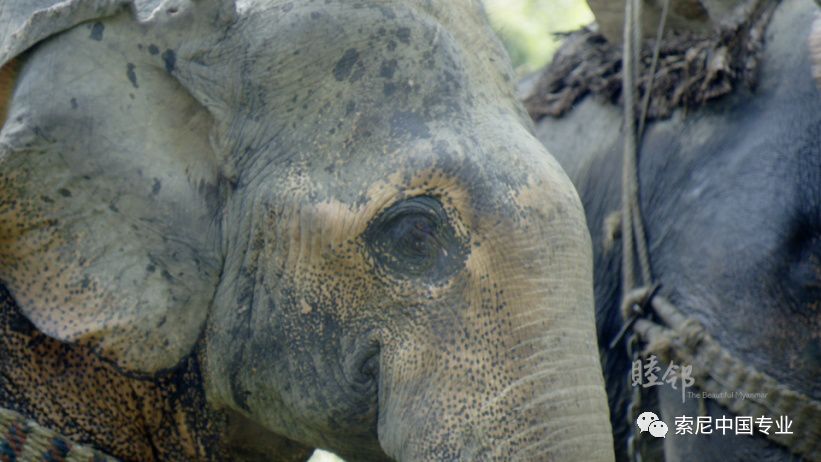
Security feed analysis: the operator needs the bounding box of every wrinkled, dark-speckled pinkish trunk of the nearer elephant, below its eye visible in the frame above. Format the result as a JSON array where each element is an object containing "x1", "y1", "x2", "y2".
[{"x1": 378, "y1": 204, "x2": 613, "y2": 461}]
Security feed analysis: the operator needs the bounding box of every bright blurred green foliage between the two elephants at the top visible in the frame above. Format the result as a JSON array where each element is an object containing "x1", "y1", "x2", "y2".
[{"x1": 484, "y1": 0, "x2": 593, "y2": 75}]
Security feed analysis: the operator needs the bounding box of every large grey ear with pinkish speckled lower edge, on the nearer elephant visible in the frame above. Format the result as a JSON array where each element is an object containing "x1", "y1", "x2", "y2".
[{"x1": 0, "y1": 0, "x2": 233, "y2": 373}]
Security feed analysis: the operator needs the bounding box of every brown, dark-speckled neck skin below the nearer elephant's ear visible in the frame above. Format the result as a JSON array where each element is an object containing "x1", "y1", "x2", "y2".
[{"x1": 0, "y1": 284, "x2": 225, "y2": 461}]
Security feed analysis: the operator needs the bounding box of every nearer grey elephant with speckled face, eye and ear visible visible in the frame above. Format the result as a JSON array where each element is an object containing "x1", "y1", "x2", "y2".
[{"x1": 0, "y1": 0, "x2": 613, "y2": 461}]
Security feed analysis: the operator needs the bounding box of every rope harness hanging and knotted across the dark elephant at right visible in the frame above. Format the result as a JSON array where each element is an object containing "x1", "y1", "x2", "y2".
[{"x1": 610, "y1": 0, "x2": 821, "y2": 462}]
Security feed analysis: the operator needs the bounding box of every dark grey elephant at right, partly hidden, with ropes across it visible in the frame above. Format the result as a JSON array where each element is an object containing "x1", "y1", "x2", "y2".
[{"x1": 522, "y1": 0, "x2": 821, "y2": 461}]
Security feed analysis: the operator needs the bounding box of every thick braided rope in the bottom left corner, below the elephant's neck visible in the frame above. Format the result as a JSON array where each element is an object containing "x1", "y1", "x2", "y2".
[{"x1": 0, "y1": 408, "x2": 117, "y2": 462}]
